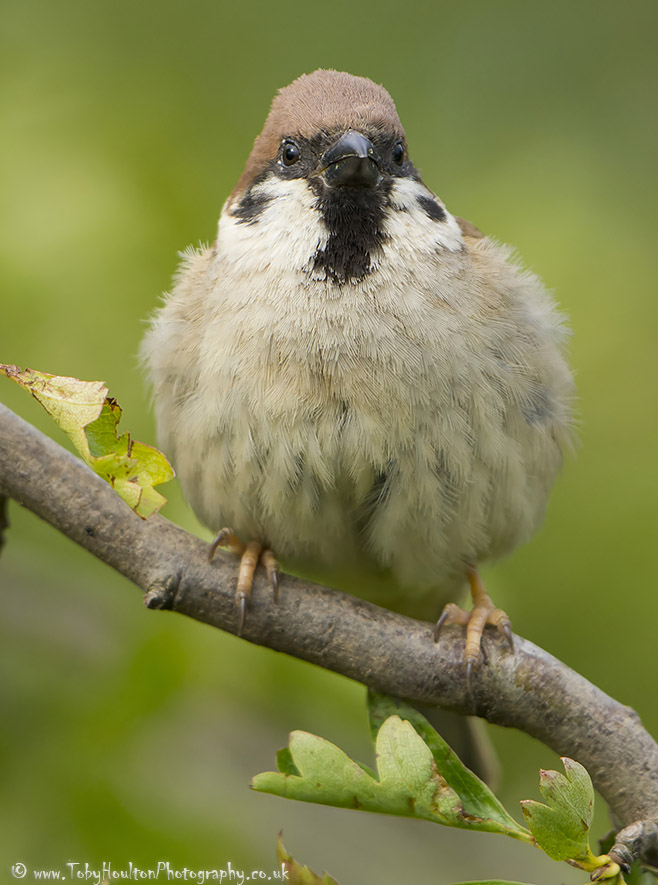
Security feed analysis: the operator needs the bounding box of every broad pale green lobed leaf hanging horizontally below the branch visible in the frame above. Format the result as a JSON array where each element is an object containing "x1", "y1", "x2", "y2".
[{"x1": 251, "y1": 698, "x2": 531, "y2": 841}]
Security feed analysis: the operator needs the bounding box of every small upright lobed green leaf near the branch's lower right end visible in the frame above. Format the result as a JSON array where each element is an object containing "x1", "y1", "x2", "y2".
[{"x1": 521, "y1": 757, "x2": 596, "y2": 866}]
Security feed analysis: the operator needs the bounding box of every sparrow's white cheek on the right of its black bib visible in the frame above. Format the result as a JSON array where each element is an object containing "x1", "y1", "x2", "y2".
[{"x1": 386, "y1": 178, "x2": 464, "y2": 253}]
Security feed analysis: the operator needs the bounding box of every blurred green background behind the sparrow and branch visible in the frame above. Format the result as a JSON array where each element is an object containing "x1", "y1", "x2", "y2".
[{"x1": 0, "y1": 0, "x2": 658, "y2": 885}]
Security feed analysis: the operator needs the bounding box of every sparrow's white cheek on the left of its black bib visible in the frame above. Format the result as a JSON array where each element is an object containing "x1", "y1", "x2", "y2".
[{"x1": 217, "y1": 178, "x2": 328, "y2": 272}]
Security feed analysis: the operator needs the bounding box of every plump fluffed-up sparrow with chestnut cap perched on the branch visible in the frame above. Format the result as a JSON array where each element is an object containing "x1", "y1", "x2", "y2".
[{"x1": 142, "y1": 69, "x2": 573, "y2": 696}]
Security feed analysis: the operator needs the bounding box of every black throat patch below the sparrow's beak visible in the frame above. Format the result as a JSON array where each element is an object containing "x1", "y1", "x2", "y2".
[{"x1": 313, "y1": 180, "x2": 392, "y2": 284}]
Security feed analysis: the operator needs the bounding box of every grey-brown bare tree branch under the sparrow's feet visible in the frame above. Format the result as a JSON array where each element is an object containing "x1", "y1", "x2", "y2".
[{"x1": 0, "y1": 405, "x2": 658, "y2": 865}]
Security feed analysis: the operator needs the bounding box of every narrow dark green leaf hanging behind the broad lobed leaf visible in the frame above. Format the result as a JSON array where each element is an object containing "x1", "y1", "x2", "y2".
[{"x1": 368, "y1": 691, "x2": 531, "y2": 842}]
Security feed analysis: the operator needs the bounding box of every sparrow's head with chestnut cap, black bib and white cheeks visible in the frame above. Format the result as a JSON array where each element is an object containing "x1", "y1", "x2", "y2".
[{"x1": 220, "y1": 70, "x2": 460, "y2": 284}]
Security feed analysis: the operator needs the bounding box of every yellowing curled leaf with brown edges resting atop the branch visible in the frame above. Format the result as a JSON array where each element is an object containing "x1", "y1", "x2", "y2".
[{"x1": 0, "y1": 364, "x2": 174, "y2": 519}]
